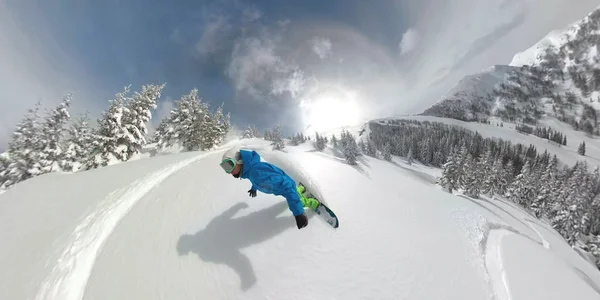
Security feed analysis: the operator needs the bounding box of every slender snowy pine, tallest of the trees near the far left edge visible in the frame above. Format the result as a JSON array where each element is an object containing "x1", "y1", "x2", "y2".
[{"x1": 39, "y1": 95, "x2": 72, "y2": 174}]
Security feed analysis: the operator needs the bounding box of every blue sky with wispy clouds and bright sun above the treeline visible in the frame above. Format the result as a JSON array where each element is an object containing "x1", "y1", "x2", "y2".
[{"x1": 0, "y1": 0, "x2": 597, "y2": 144}]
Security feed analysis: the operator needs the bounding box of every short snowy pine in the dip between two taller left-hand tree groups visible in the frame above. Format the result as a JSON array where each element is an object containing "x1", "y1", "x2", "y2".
[{"x1": 64, "y1": 113, "x2": 94, "y2": 172}]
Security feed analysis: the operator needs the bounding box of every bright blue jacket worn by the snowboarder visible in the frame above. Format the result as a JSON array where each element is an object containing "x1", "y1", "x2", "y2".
[{"x1": 240, "y1": 150, "x2": 304, "y2": 216}]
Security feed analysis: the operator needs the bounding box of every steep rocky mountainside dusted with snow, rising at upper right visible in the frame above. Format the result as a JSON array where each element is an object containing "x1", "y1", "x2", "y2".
[{"x1": 422, "y1": 8, "x2": 600, "y2": 135}]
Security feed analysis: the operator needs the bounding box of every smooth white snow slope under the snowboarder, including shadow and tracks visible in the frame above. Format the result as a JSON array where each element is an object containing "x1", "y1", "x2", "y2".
[{"x1": 0, "y1": 140, "x2": 600, "y2": 300}]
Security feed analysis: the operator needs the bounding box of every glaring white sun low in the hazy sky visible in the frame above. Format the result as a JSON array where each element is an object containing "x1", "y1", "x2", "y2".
[{"x1": 301, "y1": 88, "x2": 361, "y2": 132}]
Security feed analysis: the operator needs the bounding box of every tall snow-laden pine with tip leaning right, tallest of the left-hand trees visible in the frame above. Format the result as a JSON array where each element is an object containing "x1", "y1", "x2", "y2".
[{"x1": 122, "y1": 84, "x2": 165, "y2": 160}]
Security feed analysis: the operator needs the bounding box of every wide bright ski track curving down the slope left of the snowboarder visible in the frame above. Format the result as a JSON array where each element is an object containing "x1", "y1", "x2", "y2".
[{"x1": 35, "y1": 152, "x2": 215, "y2": 300}]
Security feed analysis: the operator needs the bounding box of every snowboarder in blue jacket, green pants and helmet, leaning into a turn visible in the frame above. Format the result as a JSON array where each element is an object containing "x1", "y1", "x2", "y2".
[{"x1": 221, "y1": 147, "x2": 319, "y2": 229}]
